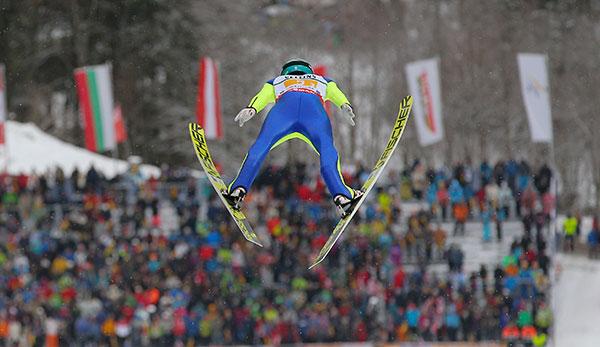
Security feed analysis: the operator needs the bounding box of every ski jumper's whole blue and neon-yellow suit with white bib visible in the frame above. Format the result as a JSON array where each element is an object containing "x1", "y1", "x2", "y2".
[{"x1": 229, "y1": 74, "x2": 354, "y2": 198}]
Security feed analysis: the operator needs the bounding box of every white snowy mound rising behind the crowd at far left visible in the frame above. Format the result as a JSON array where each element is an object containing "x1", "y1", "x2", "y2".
[{"x1": 0, "y1": 121, "x2": 160, "y2": 178}]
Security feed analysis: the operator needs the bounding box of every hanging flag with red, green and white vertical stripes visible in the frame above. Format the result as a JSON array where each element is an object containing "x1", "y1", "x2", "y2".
[{"x1": 75, "y1": 64, "x2": 116, "y2": 152}]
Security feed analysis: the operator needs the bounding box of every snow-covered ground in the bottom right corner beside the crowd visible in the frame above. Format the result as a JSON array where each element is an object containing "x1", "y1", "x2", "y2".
[{"x1": 552, "y1": 254, "x2": 600, "y2": 347}]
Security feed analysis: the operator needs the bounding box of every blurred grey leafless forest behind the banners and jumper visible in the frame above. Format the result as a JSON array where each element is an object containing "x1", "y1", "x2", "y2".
[{"x1": 0, "y1": 0, "x2": 600, "y2": 207}]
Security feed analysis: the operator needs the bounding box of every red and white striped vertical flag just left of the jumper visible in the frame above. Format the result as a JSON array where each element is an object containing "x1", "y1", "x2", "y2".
[{"x1": 196, "y1": 57, "x2": 223, "y2": 139}]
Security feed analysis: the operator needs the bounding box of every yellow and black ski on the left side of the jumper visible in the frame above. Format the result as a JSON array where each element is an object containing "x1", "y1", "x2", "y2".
[{"x1": 189, "y1": 123, "x2": 263, "y2": 247}]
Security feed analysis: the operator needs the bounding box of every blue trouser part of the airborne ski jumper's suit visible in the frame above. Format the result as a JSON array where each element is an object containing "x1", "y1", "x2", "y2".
[{"x1": 229, "y1": 91, "x2": 353, "y2": 198}]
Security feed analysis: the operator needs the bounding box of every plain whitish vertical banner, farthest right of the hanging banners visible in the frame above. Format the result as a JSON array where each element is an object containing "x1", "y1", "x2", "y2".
[{"x1": 517, "y1": 53, "x2": 552, "y2": 143}]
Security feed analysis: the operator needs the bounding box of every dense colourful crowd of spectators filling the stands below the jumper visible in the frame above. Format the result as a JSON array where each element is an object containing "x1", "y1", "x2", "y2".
[{"x1": 0, "y1": 159, "x2": 551, "y2": 346}]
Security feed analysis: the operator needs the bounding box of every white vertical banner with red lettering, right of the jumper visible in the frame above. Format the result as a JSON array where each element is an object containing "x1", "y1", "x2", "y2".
[{"x1": 406, "y1": 58, "x2": 444, "y2": 146}]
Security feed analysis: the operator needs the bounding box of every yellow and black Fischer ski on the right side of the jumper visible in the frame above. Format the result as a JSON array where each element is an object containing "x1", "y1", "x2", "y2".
[{"x1": 309, "y1": 95, "x2": 413, "y2": 269}]
